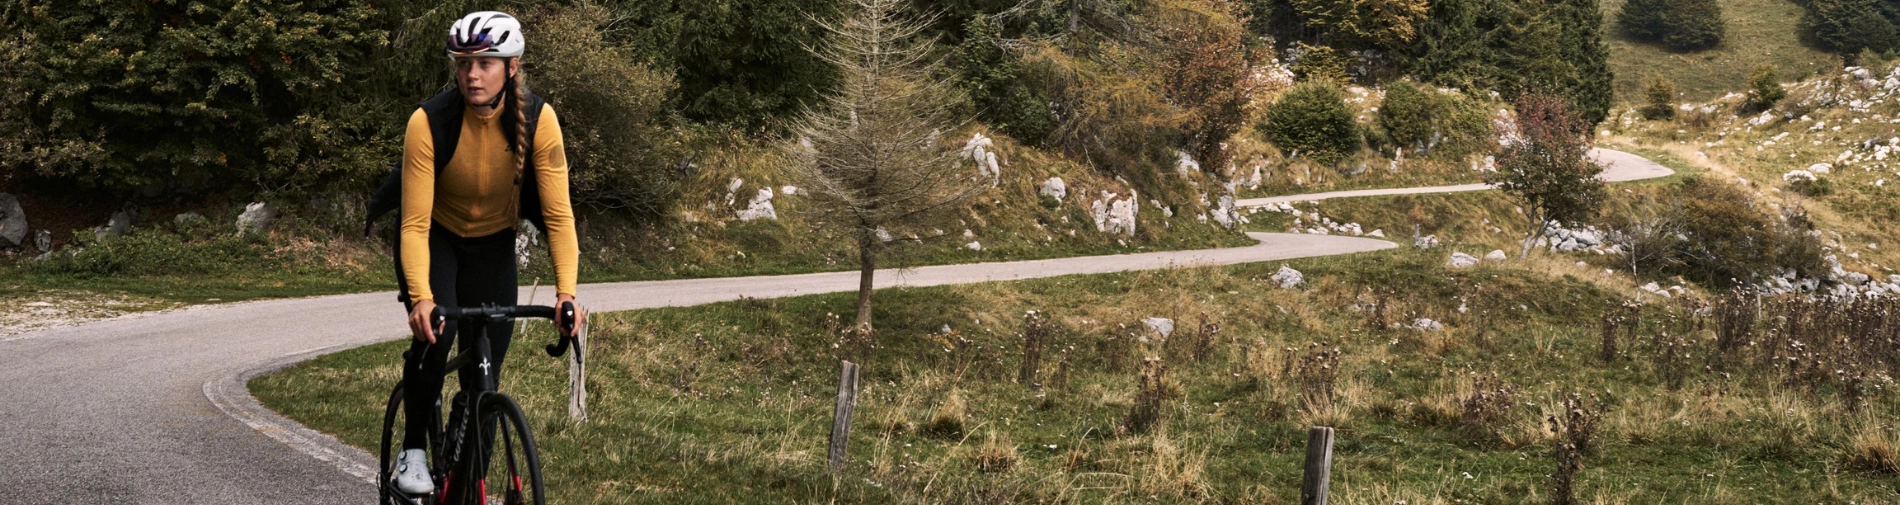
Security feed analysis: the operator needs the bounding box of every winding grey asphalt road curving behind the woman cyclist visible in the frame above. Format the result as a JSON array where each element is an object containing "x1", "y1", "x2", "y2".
[{"x1": 0, "y1": 146, "x2": 1668, "y2": 505}]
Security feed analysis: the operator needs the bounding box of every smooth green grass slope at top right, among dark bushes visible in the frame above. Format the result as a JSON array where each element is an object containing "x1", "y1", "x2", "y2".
[{"x1": 1602, "y1": 0, "x2": 1841, "y2": 104}]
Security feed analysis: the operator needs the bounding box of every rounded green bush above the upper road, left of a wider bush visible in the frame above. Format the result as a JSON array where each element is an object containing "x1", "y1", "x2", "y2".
[{"x1": 1260, "y1": 80, "x2": 1359, "y2": 163}]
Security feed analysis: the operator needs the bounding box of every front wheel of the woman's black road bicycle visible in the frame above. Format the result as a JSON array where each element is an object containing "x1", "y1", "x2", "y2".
[{"x1": 464, "y1": 393, "x2": 547, "y2": 505}]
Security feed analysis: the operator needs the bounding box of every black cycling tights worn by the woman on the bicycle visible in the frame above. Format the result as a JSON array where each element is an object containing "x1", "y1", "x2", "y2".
[{"x1": 403, "y1": 226, "x2": 517, "y2": 450}]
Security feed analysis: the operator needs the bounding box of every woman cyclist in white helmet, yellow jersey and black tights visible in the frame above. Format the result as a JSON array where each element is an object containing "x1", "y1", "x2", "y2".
[{"x1": 395, "y1": 11, "x2": 585, "y2": 494}]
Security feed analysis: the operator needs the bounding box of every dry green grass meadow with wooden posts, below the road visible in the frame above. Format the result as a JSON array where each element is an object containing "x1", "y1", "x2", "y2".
[{"x1": 251, "y1": 251, "x2": 1900, "y2": 503}]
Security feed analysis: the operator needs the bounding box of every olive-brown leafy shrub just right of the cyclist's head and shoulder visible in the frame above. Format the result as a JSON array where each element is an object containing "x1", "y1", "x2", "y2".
[{"x1": 523, "y1": 4, "x2": 684, "y2": 218}]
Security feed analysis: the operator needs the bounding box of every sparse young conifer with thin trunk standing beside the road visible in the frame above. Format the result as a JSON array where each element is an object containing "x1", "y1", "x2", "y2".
[{"x1": 785, "y1": 0, "x2": 990, "y2": 334}]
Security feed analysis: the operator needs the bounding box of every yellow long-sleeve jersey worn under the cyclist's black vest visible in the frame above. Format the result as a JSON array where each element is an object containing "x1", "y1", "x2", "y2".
[{"x1": 401, "y1": 106, "x2": 580, "y2": 302}]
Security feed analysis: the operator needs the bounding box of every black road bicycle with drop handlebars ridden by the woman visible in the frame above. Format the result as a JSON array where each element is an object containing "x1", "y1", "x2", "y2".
[{"x1": 376, "y1": 302, "x2": 581, "y2": 505}]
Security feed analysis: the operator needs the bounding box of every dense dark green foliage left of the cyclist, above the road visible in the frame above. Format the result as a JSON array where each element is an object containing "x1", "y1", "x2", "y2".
[{"x1": 0, "y1": 0, "x2": 410, "y2": 190}]
